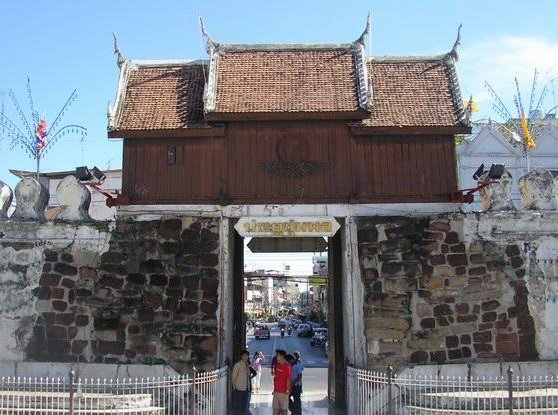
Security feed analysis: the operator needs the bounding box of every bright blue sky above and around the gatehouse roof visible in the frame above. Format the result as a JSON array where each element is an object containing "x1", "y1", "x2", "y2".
[{"x1": 0, "y1": 0, "x2": 558, "y2": 190}]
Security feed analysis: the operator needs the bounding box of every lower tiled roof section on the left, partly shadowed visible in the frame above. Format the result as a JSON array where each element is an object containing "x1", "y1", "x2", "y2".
[{"x1": 115, "y1": 63, "x2": 207, "y2": 131}]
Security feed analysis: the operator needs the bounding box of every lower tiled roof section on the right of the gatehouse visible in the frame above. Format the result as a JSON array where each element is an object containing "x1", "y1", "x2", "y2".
[{"x1": 362, "y1": 56, "x2": 468, "y2": 127}]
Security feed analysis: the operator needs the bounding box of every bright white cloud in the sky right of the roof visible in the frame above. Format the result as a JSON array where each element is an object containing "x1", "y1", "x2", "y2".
[{"x1": 459, "y1": 36, "x2": 558, "y2": 118}]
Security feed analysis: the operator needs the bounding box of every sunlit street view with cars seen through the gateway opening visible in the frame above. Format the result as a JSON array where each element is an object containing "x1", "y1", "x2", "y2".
[{"x1": 244, "y1": 238, "x2": 329, "y2": 414}]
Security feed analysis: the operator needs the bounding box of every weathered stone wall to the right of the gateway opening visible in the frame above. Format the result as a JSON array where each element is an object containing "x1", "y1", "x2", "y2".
[{"x1": 358, "y1": 213, "x2": 558, "y2": 366}]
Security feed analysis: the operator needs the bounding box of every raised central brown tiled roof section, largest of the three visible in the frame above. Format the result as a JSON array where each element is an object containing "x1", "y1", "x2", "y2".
[{"x1": 213, "y1": 48, "x2": 360, "y2": 114}]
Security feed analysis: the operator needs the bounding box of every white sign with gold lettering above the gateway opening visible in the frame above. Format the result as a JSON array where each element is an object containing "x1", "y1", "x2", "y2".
[{"x1": 235, "y1": 217, "x2": 339, "y2": 238}]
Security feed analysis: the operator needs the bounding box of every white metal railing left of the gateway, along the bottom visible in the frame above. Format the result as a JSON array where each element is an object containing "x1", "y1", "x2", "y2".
[{"x1": 0, "y1": 367, "x2": 228, "y2": 415}]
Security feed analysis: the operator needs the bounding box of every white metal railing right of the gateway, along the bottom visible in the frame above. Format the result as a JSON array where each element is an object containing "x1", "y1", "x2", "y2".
[{"x1": 347, "y1": 367, "x2": 558, "y2": 415}]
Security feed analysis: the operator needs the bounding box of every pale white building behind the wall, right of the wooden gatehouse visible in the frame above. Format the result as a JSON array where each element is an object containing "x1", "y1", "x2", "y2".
[{"x1": 457, "y1": 118, "x2": 558, "y2": 211}]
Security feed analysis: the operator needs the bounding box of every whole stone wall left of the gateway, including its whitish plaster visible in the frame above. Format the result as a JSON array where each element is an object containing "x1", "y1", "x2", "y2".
[{"x1": 0, "y1": 217, "x2": 219, "y2": 370}]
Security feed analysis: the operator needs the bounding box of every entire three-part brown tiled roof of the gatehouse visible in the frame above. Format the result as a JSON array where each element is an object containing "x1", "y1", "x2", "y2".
[{"x1": 109, "y1": 44, "x2": 465, "y2": 137}]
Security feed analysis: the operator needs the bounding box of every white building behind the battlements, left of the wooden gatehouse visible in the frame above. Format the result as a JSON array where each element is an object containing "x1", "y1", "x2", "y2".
[{"x1": 10, "y1": 169, "x2": 122, "y2": 220}]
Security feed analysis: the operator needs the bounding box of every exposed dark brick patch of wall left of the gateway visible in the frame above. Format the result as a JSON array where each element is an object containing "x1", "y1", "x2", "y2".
[{"x1": 27, "y1": 218, "x2": 219, "y2": 370}]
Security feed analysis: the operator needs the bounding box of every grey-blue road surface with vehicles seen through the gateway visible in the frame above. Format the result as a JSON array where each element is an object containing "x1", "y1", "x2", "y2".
[{"x1": 246, "y1": 325, "x2": 327, "y2": 368}]
